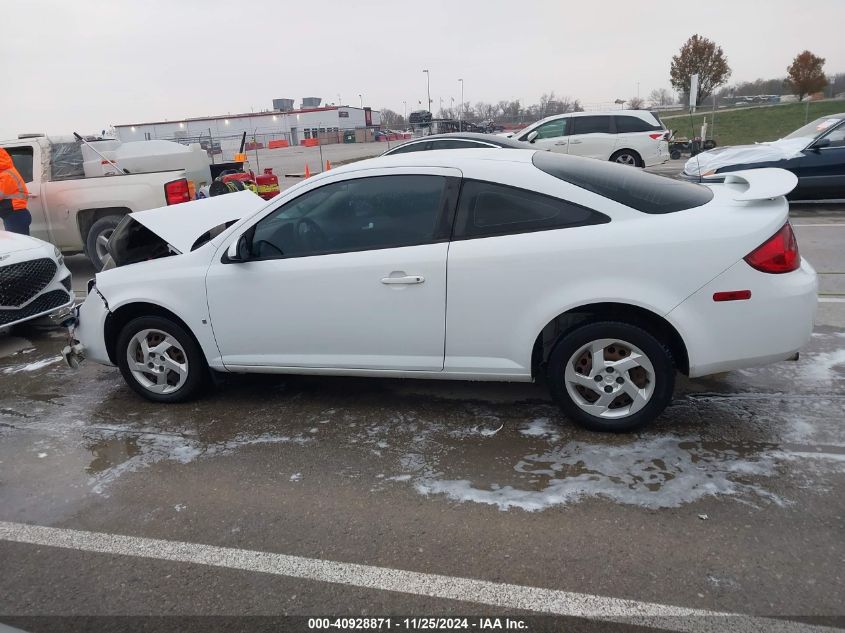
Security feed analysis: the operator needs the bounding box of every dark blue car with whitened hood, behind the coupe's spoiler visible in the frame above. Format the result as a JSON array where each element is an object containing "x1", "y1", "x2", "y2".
[{"x1": 683, "y1": 113, "x2": 845, "y2": 200}]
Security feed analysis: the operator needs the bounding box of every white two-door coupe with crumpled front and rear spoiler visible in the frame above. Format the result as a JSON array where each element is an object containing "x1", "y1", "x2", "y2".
[{"x1": 75, "y1": 149, "x2": 817, "y2": 431}]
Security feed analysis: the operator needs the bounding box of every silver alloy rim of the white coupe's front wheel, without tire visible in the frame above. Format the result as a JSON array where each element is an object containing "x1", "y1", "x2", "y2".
[{"x1": 126, "y1": 329, "x2": 188, "y2": 394}]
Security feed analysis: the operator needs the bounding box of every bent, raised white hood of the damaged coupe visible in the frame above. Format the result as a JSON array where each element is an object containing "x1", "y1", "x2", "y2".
[{"x1": 130, "y1": 191, "x2": 267, "y2": 253}]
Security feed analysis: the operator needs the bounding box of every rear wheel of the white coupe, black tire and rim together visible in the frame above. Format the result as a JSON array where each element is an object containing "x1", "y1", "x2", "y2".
[{"x1": 547, "y1": 321, "x2": 675, "y2": 433}]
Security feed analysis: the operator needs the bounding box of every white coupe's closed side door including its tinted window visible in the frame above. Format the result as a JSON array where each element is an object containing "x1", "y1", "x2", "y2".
[{"x1": 206, "y1": 168, "x2": 460, "y2": 371}]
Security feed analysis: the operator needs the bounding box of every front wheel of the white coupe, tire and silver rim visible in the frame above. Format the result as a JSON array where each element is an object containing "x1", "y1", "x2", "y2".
[{"x1": 115, "y1": 316, "x2": 208, "y2": 403}]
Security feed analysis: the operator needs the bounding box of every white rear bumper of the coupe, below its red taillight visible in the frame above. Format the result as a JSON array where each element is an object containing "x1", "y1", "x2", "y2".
[{"x1": 668, "y1": 260, "x2": 818, "y2": 377}]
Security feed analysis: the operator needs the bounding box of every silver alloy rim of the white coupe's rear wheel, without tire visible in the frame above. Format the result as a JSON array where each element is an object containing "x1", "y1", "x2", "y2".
[{"x1": 564, "y1": 338, "x2": 655, "y2": 419}]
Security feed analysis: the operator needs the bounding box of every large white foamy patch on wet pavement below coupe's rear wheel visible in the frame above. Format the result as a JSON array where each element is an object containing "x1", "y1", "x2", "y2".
[{"x1": 415, "y1": 437, "x2": 788, "y2": 512}]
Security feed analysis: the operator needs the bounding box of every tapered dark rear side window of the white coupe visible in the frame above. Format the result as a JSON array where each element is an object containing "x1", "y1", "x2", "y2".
[{"x1": 455, "y1": 180, "x2": 610, "y2": 239}]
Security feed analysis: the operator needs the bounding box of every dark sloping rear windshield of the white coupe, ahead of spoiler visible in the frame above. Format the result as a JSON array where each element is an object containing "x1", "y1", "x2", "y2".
[{"x1": 532, "y1": 152, "x2": 713, "y2": 213}]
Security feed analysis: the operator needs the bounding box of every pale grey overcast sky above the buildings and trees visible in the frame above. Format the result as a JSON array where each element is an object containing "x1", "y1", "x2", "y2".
[{"x1": 0, "y1": 0, "x2": 845, "y2": 138}]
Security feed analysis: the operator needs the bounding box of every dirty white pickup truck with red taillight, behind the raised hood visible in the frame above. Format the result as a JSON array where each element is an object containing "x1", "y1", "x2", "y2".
[{"x1": 0, "y1": 135, "x2": 199, "y2": 270}]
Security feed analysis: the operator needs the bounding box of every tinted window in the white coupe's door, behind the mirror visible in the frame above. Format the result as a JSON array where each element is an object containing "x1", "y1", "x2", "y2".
[{"x1": 252, "y1": 176, "x2": 446, "y2": 258}]
